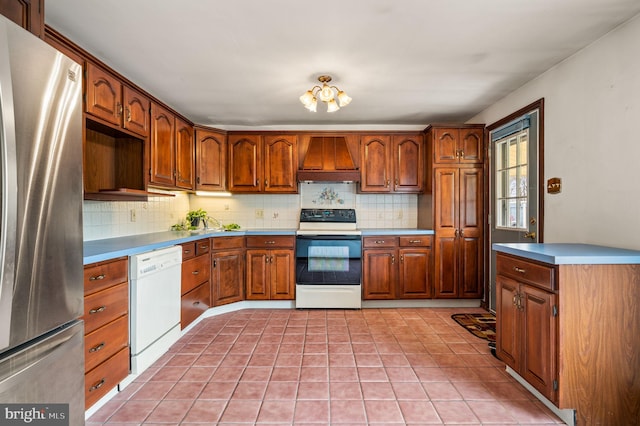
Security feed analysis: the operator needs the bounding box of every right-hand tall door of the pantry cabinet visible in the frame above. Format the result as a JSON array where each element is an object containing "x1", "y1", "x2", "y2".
[{"x1": 458, "y1": 167, "x2": 484, "y2": 298}]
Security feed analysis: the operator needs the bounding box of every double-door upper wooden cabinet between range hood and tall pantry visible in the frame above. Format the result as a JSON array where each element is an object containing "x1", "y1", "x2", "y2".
[{"x1": 360, "y1": 134, "x2": 425, "y2": 193}]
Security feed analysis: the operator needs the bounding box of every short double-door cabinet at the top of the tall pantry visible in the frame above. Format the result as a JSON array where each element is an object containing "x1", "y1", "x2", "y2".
[{"x1": 427, "y1": 125, "x2": 484, "y2": 164}]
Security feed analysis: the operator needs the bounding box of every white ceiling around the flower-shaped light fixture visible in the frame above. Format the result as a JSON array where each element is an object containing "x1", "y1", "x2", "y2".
[{"x1": 46, "y1": 0, "x2": 640, "y2": 129}]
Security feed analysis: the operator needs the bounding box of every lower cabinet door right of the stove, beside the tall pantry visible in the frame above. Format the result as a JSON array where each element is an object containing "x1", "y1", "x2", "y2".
[{"x1": 398, "y1": 247, "x2": 431, "y2": 299}]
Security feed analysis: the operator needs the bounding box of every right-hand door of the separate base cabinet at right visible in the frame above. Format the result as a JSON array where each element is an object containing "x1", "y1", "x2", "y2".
[{"x1": 519, "y1": 284, "x2": 557, "y2": 401}]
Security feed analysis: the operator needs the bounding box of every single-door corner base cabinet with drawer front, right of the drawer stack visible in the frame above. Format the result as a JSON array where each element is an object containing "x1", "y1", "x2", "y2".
[{"x1": 211, "y1": 237, "x2": 245, "y2": 306}]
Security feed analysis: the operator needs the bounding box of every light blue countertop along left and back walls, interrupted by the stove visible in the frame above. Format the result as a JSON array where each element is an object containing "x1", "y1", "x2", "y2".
[{"x1": 83, "y1": 228, "x2": 433, "y2": 265}]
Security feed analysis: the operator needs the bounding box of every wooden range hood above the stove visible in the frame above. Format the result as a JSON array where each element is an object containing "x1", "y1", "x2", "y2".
[{"x1": 298, "y1": 136, "x2": 360, "y2": 182}]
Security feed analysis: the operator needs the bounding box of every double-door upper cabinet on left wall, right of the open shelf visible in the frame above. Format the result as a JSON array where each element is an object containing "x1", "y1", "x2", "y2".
[{"x1": 149, "y1": 102, "x2": 194, "y2": 189}]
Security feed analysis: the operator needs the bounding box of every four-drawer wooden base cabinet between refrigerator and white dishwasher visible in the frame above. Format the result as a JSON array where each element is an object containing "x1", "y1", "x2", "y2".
[{"x1": 82, "y1": 257, "x2": 129, "y2": 408}]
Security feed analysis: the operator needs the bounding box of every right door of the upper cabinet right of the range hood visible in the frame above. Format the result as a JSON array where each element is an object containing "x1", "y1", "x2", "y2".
[{"x1": 393, "y1": 135, "x2": 424, "y2": 193}]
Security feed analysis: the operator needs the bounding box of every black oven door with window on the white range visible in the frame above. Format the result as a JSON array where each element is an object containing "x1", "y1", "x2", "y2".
[{"x1": 296, "y1": 235, "x2": 362, "y2": 286}]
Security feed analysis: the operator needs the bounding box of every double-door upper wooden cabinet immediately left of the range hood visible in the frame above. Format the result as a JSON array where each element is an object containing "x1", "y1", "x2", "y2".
[{"x1": 228, "y1": 134, "x2": 298, "y2": 193}]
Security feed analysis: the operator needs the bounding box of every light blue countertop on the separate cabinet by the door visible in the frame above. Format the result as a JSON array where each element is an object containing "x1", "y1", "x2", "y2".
[{"x1": 492, "y1": 243, "x2": 640, "y2": 265}]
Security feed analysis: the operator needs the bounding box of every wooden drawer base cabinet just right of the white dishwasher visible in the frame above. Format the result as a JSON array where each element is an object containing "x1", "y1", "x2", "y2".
[{"x1": 180, "y1": 238, "x2": 211, "y2": 329}]
